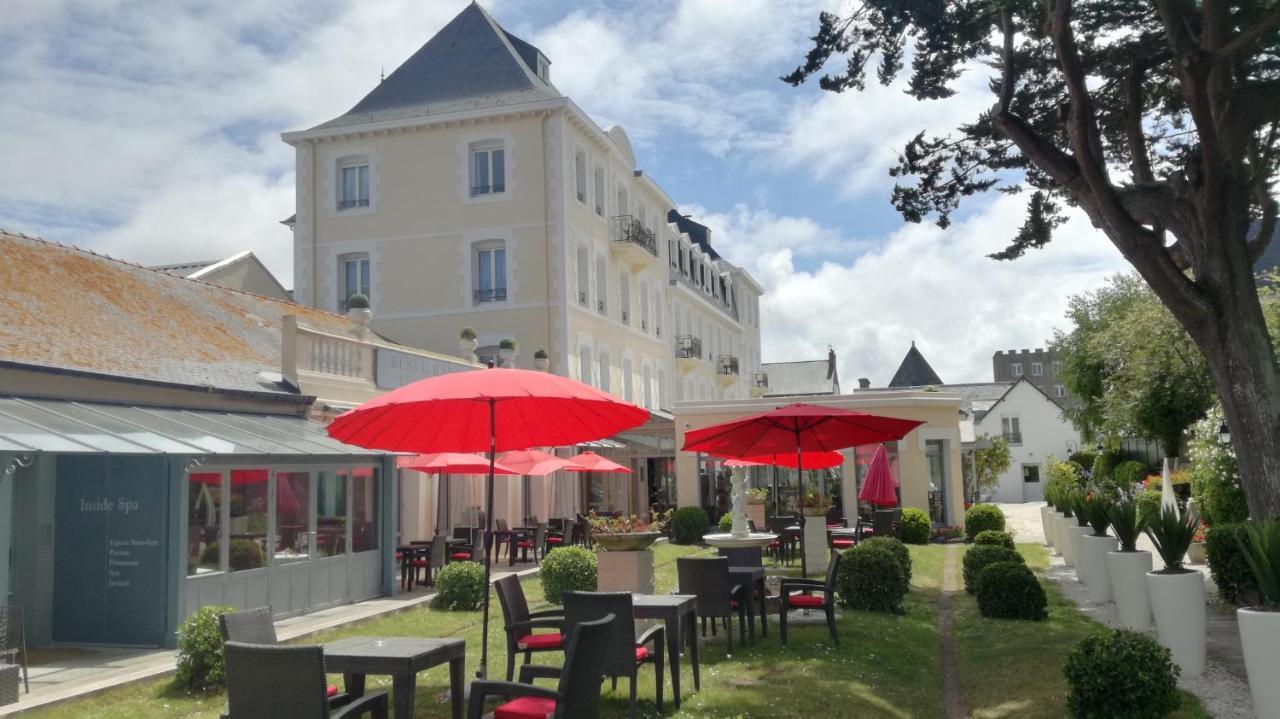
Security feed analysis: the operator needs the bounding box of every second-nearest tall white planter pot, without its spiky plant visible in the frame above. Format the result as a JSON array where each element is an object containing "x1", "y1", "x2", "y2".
[{"x1": 1147, "y1": 569, "x2": 1203, "y2": 677}]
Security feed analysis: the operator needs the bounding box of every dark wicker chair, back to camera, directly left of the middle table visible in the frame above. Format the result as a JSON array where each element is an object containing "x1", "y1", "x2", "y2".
[{"x1": 563, "y1": 591, "x2": 667, "y2": 716}]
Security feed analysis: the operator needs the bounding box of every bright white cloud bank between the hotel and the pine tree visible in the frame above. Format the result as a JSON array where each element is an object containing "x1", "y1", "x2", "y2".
[{"x1": 699, "y1": 190, "x2": 1125, "y2": 386}]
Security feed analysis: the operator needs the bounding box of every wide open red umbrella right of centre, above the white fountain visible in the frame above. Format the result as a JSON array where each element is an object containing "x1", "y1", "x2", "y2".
[{"x1": 682, "y1": 403, "x2": 924, "y2": 574}]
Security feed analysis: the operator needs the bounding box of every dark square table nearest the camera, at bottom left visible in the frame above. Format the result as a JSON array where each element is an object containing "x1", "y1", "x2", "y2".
[{"x1": 324, "y1": 637, "x2": 467, "y2": 719}]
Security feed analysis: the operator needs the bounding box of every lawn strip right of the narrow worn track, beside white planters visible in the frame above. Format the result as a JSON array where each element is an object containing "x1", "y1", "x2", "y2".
[{"x1": 952, "y1": 544, "x2": 1208, "y2": 719}]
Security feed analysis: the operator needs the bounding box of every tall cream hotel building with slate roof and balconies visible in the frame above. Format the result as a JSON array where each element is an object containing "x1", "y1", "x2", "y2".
[{"x1": 283, "y1": 4, "x2": 765, "y2": 531}]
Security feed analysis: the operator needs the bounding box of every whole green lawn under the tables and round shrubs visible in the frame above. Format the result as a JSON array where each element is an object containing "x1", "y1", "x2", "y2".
[{"x1": 20, "y1": 545, "x2": 1207, "y2": 719}]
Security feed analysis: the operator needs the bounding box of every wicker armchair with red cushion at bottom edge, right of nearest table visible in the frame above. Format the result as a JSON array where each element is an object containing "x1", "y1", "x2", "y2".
[{"x1": 467, "y1": 614, "x2": 617, "y2": 719}]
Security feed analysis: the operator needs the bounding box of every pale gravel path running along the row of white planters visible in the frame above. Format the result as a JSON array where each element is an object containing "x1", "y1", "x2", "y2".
[{"x1": 997, "y1": 502, "x2": 1257, "y2": 719}]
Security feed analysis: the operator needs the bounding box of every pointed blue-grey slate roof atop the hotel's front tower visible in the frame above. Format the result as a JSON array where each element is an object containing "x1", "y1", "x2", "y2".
[{"x1": 312, "y1": 3, "x2": 561, "y2": 129}]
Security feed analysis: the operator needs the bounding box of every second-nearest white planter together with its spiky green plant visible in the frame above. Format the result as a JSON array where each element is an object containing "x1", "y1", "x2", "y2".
[{"x1": 1146, "y1": 507, "x2": 1207, "y2": 677}]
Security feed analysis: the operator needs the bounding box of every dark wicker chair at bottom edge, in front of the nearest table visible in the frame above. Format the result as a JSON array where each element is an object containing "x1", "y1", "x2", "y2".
[{"x1": 223, "y1": 641, "x2": 387, "y2": 719}]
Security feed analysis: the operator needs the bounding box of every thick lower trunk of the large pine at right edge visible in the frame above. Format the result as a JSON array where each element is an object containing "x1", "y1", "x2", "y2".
[{"x1": 1192, "y1": 283, "x2": 1280, "y2": 519}]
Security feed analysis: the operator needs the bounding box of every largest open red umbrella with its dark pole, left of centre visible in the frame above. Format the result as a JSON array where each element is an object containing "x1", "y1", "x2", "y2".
[{"x1": 328, "y1": 368, "x2": 649, "y2": 677}]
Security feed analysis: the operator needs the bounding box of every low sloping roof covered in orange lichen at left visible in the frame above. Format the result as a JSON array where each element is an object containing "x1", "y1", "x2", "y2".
[{"x1": 0, "y1": 230, "x2": 349, "y2": 391}]
